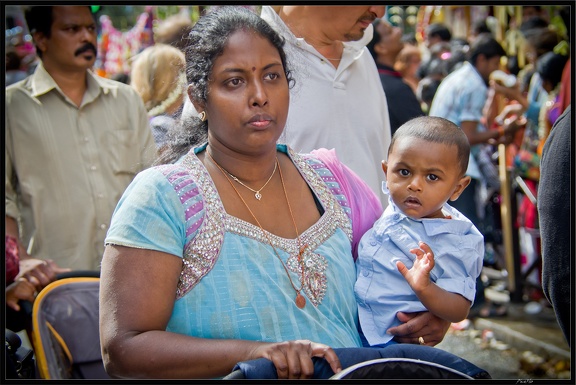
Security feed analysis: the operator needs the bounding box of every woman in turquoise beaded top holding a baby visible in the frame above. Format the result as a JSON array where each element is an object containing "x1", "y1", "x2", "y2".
[{"x1": 100, "y1": 7, "x2": 449, "y2": 378}]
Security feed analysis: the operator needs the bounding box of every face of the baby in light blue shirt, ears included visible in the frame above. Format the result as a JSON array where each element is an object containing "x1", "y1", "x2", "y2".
[{"x1": 382, "y1": 138, "x2": 470, "y2": 218}]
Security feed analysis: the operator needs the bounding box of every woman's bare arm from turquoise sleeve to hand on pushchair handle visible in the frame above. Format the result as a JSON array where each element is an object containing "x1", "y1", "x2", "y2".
[{"x1": 100, "y1": 245, "x2": 341, "y2": 379}]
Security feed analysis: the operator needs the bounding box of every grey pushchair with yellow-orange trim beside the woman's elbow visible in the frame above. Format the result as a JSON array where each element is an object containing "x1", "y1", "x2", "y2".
[{"x1": 32, "y1": 276, "x2": 109, "y2": 379}]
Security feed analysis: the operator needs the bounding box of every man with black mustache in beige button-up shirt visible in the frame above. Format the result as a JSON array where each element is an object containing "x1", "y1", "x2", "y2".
[{"x1": 5, "y1": 6, "x2": 156, "y2": 270}]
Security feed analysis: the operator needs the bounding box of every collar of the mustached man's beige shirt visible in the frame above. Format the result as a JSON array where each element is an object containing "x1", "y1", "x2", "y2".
[{"x1": 30, "y1": 61, "x2": 118, "y2": 99}]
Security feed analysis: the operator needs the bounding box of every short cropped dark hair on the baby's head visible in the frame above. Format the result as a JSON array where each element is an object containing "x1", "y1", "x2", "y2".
[{"x1": 388, "y1": 116, "x2": 470, "y2": 175}]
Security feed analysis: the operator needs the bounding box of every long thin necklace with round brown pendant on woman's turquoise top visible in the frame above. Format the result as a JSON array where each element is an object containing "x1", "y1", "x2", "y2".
[{"x1": 206, "y1": 149, "x2": 308, "y2": 309}]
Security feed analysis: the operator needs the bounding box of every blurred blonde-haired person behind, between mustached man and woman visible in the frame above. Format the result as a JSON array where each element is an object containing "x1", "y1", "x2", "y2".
[{"x1": 130, "y1": 44, "x2": 186, "y2": 149}]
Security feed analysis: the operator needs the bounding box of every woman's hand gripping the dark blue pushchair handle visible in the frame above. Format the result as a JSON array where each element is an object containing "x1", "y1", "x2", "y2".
[{"x1": 253, "y1": 340, "x2": 342, "y2": 379}]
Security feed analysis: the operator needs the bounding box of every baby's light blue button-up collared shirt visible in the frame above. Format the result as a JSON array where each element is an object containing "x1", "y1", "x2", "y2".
[{"x1": 354, "y1": 195, "x2": 484, "y2": 345}]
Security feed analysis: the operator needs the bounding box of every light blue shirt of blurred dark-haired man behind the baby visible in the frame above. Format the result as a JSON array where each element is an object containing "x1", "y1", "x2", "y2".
[{"x1": 429, "y1": 62, "x2": 488, "y2": 180}]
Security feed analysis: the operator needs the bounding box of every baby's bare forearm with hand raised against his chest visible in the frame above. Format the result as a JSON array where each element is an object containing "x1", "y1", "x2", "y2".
[{"x1": 396, "y1": 242, "x2": 471, "y2": 322}]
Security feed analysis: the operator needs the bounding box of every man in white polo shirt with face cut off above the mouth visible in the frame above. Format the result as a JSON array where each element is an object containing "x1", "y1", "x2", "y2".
[{"x1": 261, "y1": 6, "x2": 391, "y2": 207}]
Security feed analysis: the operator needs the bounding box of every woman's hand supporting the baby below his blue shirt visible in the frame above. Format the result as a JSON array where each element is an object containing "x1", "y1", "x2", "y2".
[{"x1": 387, "y1": 311, "x2": 451, "y2": 346}]
